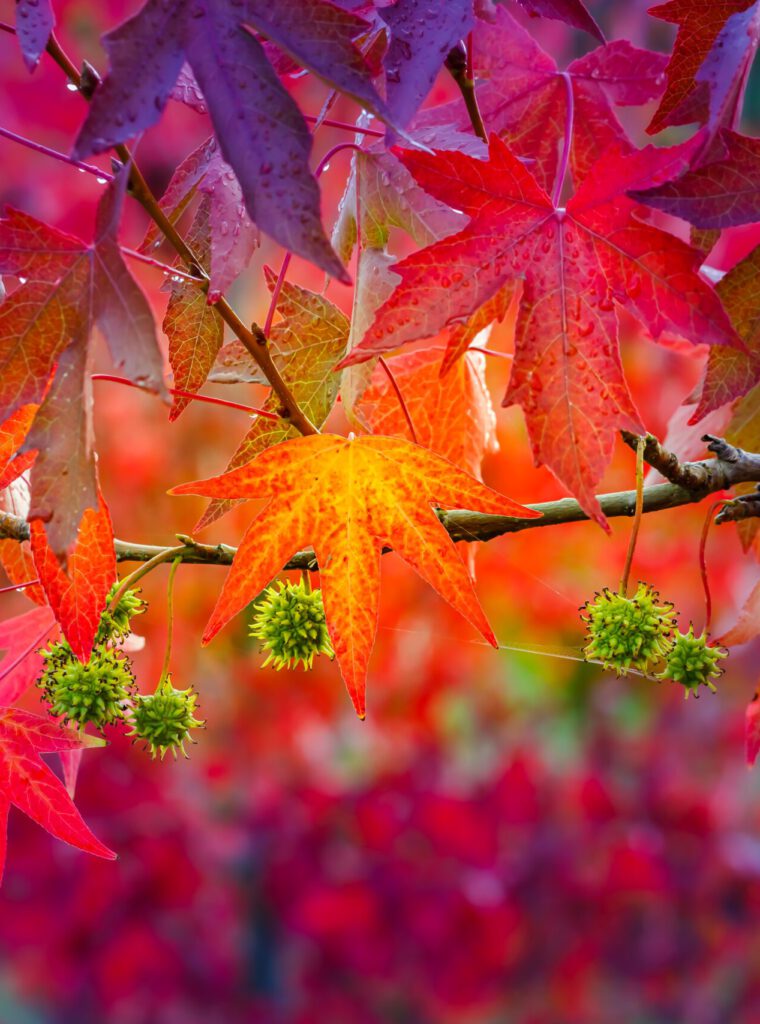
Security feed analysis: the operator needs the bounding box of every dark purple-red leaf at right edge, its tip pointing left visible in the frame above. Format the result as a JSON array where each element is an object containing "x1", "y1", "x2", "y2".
[{"x1": 631, "y1": 129, "x2": 760, "y2": 228}]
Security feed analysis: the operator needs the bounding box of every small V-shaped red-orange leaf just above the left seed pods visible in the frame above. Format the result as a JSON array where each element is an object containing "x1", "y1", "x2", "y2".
[{"x1": 30, "y1": 497, "x2": 116, "y2": 662}]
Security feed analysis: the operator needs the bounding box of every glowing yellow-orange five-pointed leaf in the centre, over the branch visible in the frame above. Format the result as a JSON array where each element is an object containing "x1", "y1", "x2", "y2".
[{"x1": 170, "y1": 434, "x2": 538, "y2": 718}]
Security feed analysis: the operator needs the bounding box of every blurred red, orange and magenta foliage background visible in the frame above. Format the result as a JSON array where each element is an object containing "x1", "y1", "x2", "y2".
[{"x1": 0, "y1": 0, "x2": 760, "y2": 1024}]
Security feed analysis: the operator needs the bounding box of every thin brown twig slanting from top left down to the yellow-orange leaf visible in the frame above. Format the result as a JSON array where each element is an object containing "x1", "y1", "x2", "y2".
[{"x1": 42, "y1": 35, "x2": 319, "y2": 434}]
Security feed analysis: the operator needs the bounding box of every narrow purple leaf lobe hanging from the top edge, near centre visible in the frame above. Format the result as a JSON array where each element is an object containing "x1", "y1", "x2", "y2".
[{"x1": 378, "y1": 0, "x2": 474, "y2": 127}]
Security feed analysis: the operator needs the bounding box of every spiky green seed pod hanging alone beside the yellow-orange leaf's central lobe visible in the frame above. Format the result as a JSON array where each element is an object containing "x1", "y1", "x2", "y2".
[{"x1": 251, "y1": 580, "x2": 334, "y2": 671}]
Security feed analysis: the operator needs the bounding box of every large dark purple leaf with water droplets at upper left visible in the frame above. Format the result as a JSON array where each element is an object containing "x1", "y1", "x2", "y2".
[{"x1": 75, "y1": 0, "x2": 401, "y2": 281}]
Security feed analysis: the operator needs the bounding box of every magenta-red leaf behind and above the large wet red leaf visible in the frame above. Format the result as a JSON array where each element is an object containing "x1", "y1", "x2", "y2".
[{"x1": 413, "y1": 7, "x2": 667, "y2": 189}]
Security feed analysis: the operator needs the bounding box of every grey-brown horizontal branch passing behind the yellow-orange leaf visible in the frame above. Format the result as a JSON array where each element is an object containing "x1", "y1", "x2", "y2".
[{"x1": 0, "y1": 434, "x2": 760, "y2": 569}]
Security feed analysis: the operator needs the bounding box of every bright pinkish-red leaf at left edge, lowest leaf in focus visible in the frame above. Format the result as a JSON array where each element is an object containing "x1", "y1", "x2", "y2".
[{"x1": 0, "y1": 708, "x2": 116, "y2": 878}]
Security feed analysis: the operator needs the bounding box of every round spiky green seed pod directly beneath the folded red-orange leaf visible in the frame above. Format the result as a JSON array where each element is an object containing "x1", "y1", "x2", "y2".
[{"x1": 38, "y1": 640, "x2": 134, "y2": 729}]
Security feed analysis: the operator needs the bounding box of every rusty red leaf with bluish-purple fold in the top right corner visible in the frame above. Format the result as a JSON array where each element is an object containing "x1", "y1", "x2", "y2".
[{"x1": 647, "y1": 0, "x2": 760, "y2": 134}]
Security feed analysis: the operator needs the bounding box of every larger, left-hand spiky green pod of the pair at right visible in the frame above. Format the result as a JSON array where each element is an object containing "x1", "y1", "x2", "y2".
[{"x1": 581, "y1": 583, "x2": 676, "y2": 676}]
